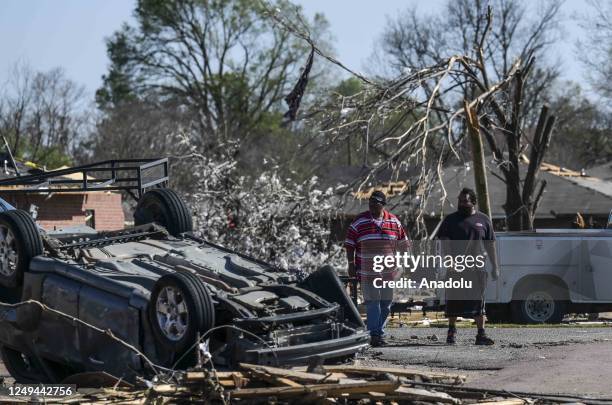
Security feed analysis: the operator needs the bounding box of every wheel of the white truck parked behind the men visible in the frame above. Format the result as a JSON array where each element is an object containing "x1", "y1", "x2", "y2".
[{"x1": 511, "y1": 282, "x2": 567, "y2": 323}]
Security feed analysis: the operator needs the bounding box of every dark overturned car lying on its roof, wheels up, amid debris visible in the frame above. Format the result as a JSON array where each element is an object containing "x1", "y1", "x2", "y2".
[{"x1": 0, "y1": 159, "x2": 368, "y2": 383}]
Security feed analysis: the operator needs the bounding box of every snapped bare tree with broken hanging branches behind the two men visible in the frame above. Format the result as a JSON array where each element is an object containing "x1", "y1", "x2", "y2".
[{"x1": 266, "y1": 3, "x2": 554, "y2": 232}]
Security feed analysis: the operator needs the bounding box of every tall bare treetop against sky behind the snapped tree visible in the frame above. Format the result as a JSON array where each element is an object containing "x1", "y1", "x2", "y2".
[{"x1": 377, "y1": 0, "x2": 562, "y2": 123}]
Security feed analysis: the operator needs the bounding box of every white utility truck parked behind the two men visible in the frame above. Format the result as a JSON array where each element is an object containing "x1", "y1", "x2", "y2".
[{"x1": 436, "y1": 229, "x2": 612, "y2": 323}]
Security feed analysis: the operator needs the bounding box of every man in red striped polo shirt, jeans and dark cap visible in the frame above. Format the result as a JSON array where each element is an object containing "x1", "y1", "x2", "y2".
[{"x1": 344, "y1": 191, "x2": 410, "y2": 347}]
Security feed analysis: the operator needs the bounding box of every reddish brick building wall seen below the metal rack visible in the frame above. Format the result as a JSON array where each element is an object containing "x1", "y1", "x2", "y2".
[{"x1": 0, "y1": 191, "x2": 125, "y2": 231}]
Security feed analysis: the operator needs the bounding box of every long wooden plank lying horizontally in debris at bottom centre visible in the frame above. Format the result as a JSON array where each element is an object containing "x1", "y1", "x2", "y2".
[{"x1": 230, "y1": 381, "x2": 400, "y2": 398}]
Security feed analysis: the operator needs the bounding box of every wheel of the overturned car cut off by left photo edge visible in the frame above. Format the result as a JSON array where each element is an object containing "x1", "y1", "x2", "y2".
[{"x1": 0, "y1": 210, "x2": 43, "y2": 289}]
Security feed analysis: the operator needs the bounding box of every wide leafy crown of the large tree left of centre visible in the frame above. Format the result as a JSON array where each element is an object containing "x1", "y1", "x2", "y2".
[{"x1": 97, "y1": 0, "x2": 327, "y2": 142}]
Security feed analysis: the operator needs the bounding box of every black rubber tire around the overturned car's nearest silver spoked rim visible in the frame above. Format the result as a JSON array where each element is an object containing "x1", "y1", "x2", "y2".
[{"x1": 148, "y1": 272, "x2": 215, "y2": 361}]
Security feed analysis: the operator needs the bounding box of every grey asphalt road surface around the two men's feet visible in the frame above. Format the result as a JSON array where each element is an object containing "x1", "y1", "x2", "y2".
[{"x1": 361, "y1": 327, "x2": 612, "y2": 398}]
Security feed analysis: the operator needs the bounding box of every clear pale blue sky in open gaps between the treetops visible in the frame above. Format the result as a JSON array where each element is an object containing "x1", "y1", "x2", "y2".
[{"x1": 0, "y1": 0, "x2": 585, "y2": 98}]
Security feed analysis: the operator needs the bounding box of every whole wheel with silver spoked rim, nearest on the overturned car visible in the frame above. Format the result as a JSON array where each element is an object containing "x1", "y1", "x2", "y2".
[{"x1": 148, "y1": 272, "x2": 215, "y2": 361}]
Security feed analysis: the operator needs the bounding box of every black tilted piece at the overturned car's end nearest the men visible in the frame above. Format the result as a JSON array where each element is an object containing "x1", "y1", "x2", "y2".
[{"x1": 300, "y1": 265, "x2": 365, "y2": 327}]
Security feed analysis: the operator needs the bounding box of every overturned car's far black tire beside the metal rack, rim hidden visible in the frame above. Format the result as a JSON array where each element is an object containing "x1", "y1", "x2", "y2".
[{"x1": 134, "y1": 188, "x2": 193, "y2": 236}]
